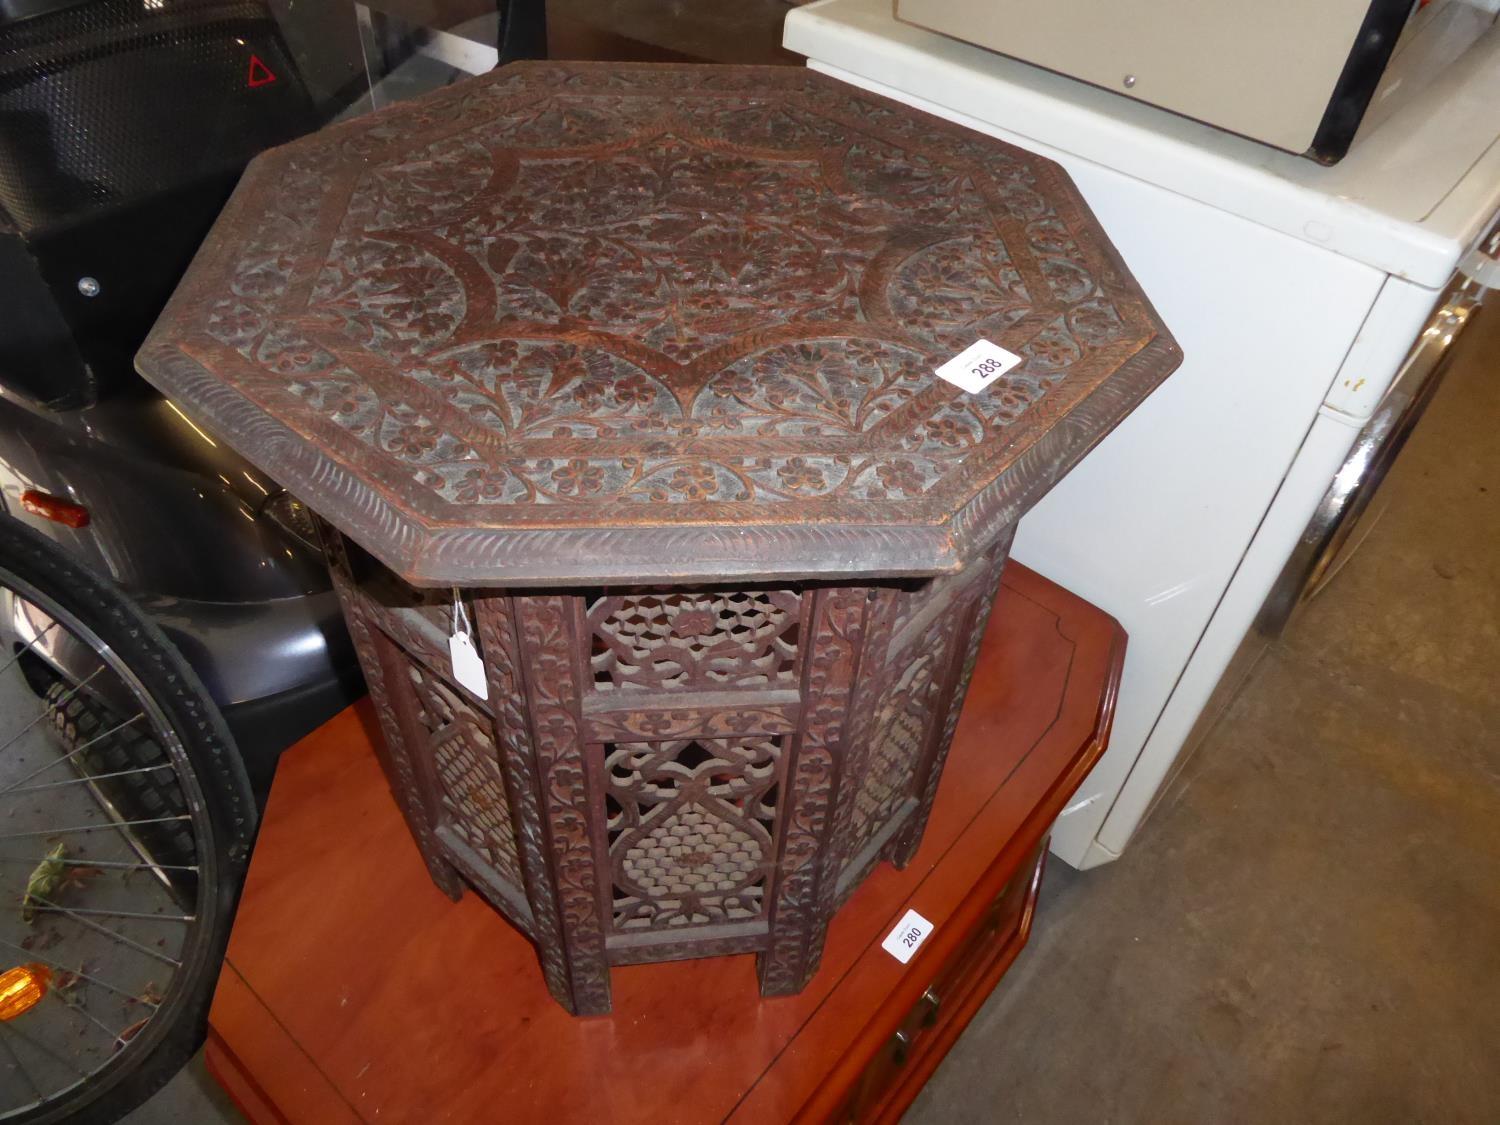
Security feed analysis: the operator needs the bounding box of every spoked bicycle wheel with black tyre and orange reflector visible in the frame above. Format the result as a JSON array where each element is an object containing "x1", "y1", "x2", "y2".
[{"x1": 0, "y1": 518, "x2": 255, "y2": 1125}]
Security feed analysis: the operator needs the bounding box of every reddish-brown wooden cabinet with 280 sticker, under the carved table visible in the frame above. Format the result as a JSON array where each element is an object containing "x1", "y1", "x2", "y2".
[{"x1": 209, "y1": 564, "x2": 1125, "y2": 1125}]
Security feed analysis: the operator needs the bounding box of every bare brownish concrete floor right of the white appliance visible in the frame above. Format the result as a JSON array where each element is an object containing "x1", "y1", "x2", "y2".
[{"x1": 906, "y1": 309, "x2": 1500, "y2": 1125}]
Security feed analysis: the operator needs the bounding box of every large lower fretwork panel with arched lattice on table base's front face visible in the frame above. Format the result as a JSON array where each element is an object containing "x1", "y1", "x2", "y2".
[{"x1": 602, "y1": 737, "x2": 785, "y2": 933}]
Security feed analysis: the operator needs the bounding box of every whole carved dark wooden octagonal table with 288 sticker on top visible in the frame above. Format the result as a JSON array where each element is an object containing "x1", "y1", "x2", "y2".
[{"x1": 138, "y1": 63, "x2": 1179, "y2": 1014}]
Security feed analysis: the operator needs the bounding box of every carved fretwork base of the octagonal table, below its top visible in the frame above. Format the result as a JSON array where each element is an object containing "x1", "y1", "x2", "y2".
[{"x1": 326, "y1": 528, "x2": 1010, "y2": 1016}]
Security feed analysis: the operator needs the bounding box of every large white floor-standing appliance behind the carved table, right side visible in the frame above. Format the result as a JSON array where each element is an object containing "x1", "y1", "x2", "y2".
[{"x1": 785, "y1": 0, "x2": 1500, "y2": 867}]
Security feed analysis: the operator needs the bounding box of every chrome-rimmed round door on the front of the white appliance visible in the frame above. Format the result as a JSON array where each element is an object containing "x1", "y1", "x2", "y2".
[{"x1": 1256, "y1": 264, "x2": 1500, "y2": 641}]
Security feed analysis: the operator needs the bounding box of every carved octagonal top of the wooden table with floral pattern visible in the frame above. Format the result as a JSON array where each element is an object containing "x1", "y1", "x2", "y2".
[{"x1": 137, "y1": 63, "x2": 1181, "y2": 585}]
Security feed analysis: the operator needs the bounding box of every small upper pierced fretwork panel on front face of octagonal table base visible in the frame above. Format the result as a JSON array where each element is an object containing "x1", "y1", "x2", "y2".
[{"x1": 588, "y1": 590, "x2": 801, "y2": 692}]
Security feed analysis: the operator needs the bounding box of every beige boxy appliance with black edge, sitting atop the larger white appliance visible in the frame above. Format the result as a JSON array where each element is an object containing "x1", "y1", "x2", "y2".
[{"x1": 896, "y1": 0, "x2": 1496, "y2": 164}]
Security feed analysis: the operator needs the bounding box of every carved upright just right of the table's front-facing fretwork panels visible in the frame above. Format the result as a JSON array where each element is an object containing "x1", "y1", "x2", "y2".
[{"x1": 759, "y1": 587, "x2": 869, "y2": 996}]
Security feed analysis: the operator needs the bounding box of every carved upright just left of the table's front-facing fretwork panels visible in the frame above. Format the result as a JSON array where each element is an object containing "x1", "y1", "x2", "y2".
[{"x1": 512, "y1": 597, "x2": 609, "y2": 1016}]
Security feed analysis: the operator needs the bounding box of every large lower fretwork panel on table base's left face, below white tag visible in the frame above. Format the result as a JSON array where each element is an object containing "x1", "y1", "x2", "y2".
[{"x1": 410, "y1": 665, "x2": 524, "y2": 888}]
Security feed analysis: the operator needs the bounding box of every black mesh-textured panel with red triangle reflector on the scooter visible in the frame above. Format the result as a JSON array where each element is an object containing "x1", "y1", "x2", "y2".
[{"x1": 0, "y1": 0, "x2": 318, "y2": 236}]
